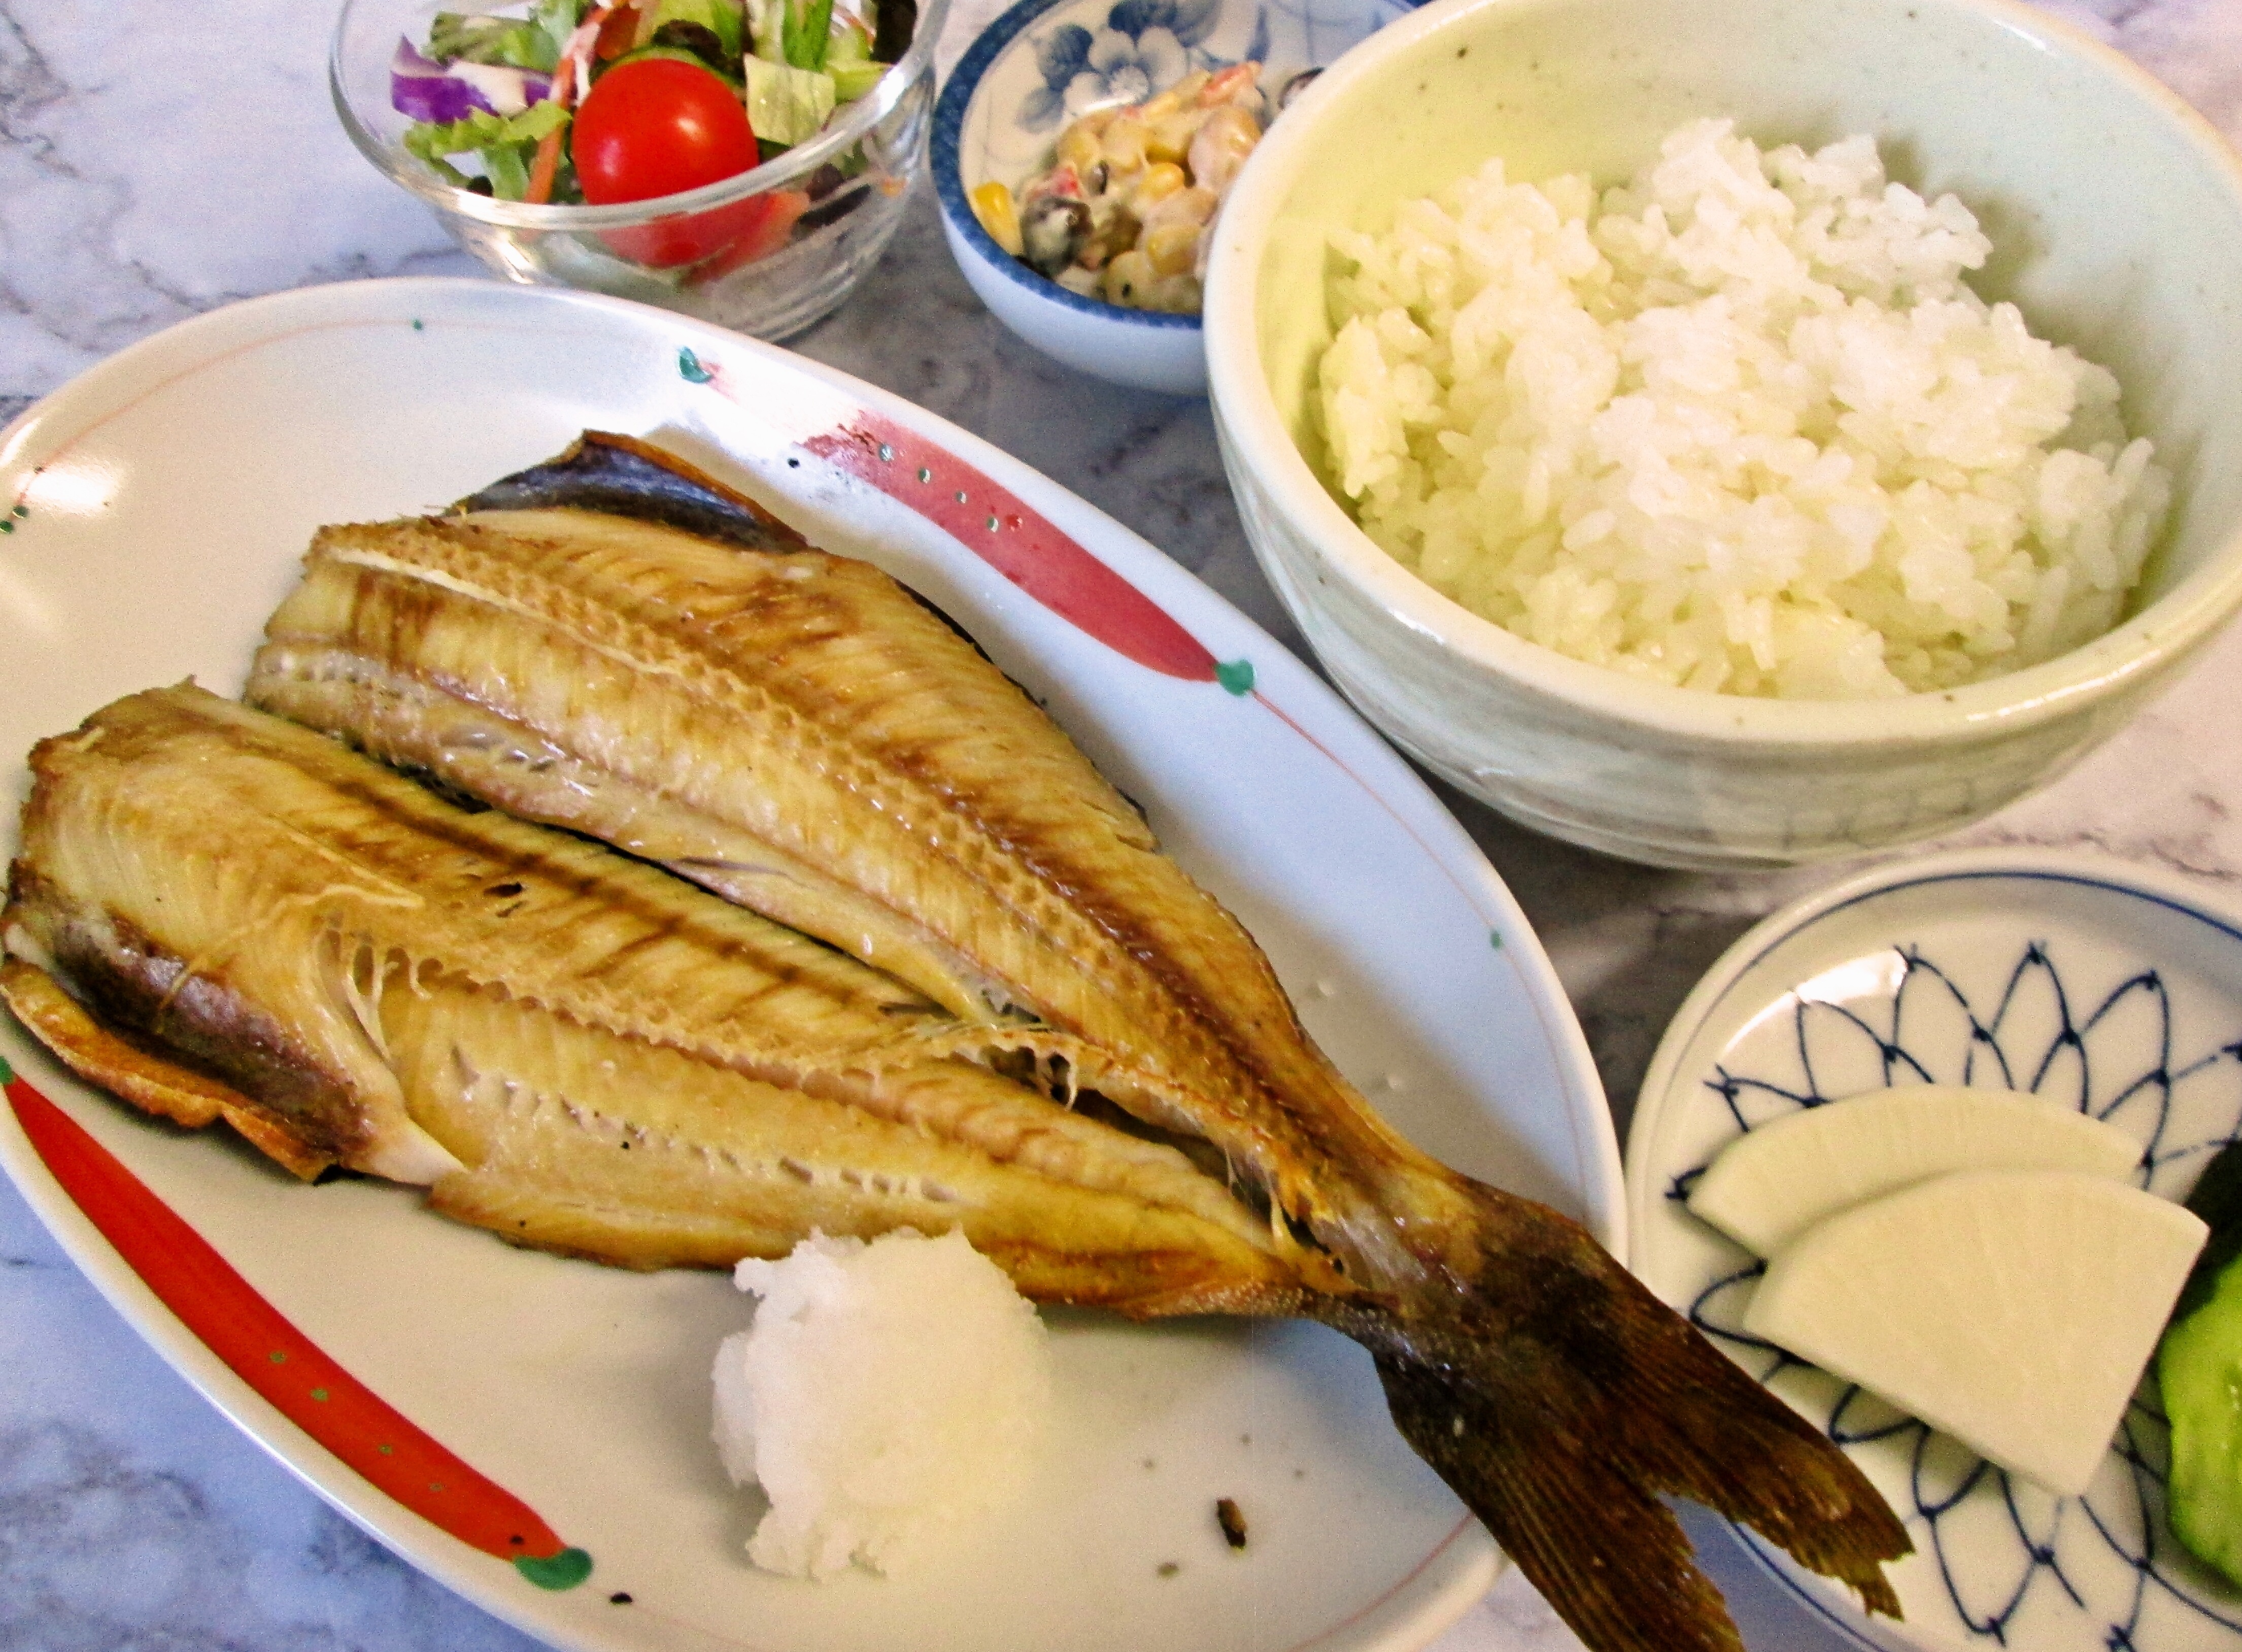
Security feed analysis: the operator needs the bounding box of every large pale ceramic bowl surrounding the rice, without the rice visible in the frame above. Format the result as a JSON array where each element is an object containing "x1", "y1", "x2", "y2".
[{"x1": 1206, "y1": 0, "x2": 2242, "y2": 867}]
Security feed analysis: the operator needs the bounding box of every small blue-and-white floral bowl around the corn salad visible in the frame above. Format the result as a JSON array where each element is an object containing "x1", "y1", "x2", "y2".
[{"x1": 933, "y1": 0, "x2": 1412, "y2": 394}]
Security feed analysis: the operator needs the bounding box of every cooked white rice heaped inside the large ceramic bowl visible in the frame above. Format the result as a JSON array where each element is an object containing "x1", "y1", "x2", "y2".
[{"x1": 1320, "y1": 121, "x2": 2170, "y2": 699}]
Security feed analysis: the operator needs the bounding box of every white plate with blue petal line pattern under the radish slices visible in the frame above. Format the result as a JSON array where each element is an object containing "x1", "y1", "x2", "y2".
[{"x1": 1627, "y1": 850, "x2": 2242, "y2": 1652}]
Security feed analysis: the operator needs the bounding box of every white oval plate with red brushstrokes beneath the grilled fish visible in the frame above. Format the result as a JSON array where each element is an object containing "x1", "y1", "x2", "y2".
[{"x1": 0, "y1": 280, "x2": 1623, "y2": 1652}]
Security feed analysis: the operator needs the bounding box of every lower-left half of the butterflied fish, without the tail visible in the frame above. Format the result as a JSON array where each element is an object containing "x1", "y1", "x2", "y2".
[{"x1": 0, "y1": 688, "x2": 1300, "y2": 1313}]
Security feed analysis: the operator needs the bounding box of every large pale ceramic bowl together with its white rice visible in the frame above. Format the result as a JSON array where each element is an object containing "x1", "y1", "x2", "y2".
[{"x1": 1206, "y1": 0, "x2": 2242, "y2": 867}]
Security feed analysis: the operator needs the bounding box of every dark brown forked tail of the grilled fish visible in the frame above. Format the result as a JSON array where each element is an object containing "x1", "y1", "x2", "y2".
[{"x1": 1334, "y1": 1184, "x2": 1913, "y2": 1652}]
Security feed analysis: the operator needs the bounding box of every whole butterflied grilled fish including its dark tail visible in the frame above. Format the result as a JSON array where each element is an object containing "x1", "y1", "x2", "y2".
[{"x1": 0, "y1": 437, "x2": 1908, "y2": 1652}]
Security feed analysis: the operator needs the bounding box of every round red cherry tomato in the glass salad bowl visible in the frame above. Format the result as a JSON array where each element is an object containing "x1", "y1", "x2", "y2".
[{"x1": 569, "y1": 58, "x2": 760, "y2": 269}]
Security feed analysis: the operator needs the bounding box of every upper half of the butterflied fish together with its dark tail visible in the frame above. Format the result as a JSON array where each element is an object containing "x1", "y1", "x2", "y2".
[{"x1": 227, "y1": 437, "x2": 1908, "y2": 1652}]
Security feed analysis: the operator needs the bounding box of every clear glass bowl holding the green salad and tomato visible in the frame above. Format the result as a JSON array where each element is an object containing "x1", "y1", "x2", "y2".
[{"x1": 327, "y1": 0, "x2": 948, "y2": 339}]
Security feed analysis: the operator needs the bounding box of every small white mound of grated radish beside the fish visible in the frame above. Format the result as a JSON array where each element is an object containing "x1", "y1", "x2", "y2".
[{"x1": 715, "y1": 1231, "x2": 1051, "y2": 1578}]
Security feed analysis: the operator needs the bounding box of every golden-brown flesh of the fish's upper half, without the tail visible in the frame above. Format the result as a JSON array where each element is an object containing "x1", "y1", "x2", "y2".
[{"x1": 247, "y1": 444, "x2": 1455, "y2": 1275}]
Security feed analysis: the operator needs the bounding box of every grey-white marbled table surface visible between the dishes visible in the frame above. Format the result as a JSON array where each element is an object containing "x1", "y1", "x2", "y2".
[{"x1": 0, "y1": 0, "x2": 2242, "y2": 1652}]
